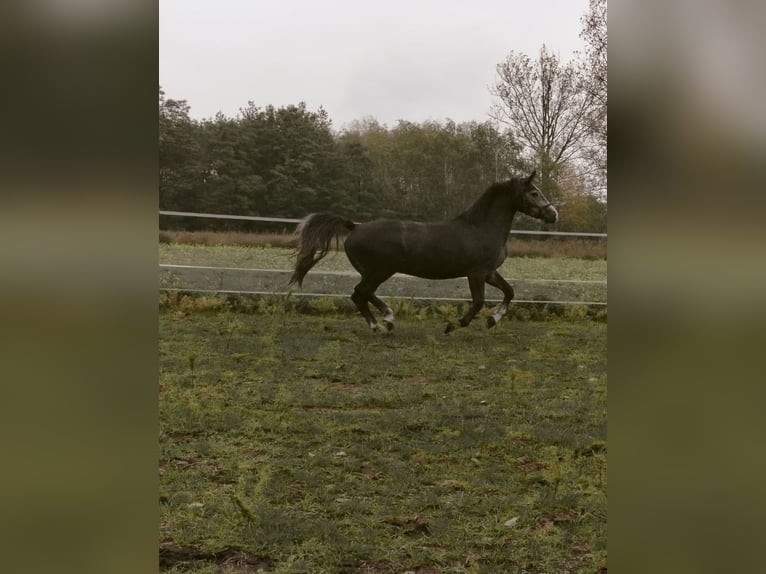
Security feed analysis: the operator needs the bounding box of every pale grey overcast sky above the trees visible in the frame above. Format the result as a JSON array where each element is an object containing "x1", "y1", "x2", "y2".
[{"x1": 159, "y1": 0, "x2": 587, "y2": 129}]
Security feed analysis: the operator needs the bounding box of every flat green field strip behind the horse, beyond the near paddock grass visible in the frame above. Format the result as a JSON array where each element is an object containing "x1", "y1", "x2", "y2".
[{"x1": 159, "y1": 244, "x2": 607, "y2": 308}]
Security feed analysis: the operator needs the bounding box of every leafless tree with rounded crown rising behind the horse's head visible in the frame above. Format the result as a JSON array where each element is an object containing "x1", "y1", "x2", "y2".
[{"x1": 490, "y1": 46, "x2": 593, "y2": 197}]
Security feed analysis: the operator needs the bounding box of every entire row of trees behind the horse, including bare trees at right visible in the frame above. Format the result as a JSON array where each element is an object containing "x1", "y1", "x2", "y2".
[{"x1": 159, "y1": 0, "x2": 606, "y2": 232}]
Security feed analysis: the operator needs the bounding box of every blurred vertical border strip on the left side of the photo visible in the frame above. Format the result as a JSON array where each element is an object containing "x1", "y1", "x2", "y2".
[{"x1": 0, "y1": 0, "x2": 158, "y2": 573}]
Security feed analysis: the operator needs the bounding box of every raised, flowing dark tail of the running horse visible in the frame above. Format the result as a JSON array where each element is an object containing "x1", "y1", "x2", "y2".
[{"x1": 287, "y1": 213, "x2": 356, "y2": 287}]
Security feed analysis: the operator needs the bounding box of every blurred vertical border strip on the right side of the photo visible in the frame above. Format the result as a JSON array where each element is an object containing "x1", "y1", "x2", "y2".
[{"x1": 609, "y1": 0, "x2": 766, "y2": 574}]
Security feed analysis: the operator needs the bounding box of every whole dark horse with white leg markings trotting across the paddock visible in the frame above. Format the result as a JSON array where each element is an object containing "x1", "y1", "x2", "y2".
[{"x1": 288, "y1": 171, "x2": 558, "y2": 333}]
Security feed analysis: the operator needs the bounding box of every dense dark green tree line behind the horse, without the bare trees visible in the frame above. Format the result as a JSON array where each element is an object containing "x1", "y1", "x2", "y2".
[{"x1": 159, "y1": 97, "x2": 606, "y2": 231}]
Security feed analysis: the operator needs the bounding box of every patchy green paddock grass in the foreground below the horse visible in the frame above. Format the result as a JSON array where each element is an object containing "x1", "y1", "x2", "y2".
[{"x1": 159, "y1": 304, "x2": 607, "y2": 574}]
